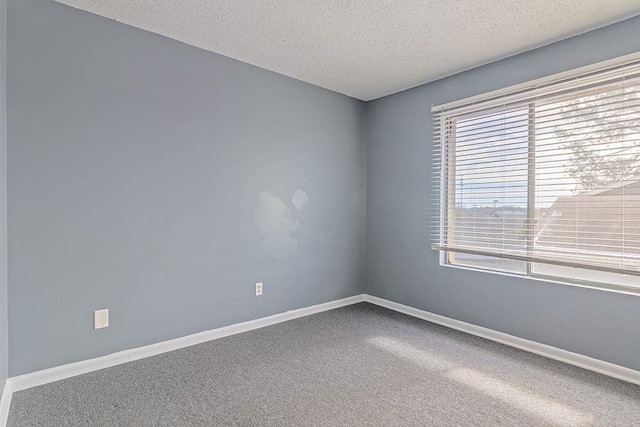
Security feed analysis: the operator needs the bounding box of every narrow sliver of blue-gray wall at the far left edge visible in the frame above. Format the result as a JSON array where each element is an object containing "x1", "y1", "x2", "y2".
[{"x1": 0, "y1": 0, "x2": 9, "y2": 387}]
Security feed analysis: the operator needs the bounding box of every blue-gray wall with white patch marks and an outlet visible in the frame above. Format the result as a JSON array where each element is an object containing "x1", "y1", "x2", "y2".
[{"x1": 7, "y1": 0, "x2": 365, "y2": 376}]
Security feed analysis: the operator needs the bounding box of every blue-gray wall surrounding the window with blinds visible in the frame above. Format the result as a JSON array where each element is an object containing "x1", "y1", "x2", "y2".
[{"x1": 366, "y1": 17, "x2": 640, "y2": 370}]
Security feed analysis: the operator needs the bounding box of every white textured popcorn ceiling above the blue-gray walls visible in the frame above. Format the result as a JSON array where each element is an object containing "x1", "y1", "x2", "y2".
[{"x1": 56, "y1": 0, "x2": 640, "y2": 101}]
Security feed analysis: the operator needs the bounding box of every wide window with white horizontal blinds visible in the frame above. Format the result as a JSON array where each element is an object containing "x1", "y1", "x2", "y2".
[{"x1": 433, "y1": 56, "x2": 640, "y2": 292}]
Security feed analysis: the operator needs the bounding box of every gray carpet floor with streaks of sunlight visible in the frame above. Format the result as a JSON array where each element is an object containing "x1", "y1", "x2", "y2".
[{"x1": 8, "y1": 303, "x2": 640, "y2": 426}]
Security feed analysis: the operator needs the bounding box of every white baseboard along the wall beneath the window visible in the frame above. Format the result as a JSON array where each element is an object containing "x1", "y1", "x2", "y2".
[{"x1": 364, "y1": 294, "x2": 640, "y2": 385}]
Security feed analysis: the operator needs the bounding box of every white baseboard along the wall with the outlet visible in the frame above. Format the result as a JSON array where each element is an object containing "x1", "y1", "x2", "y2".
[{"x1": 8, "y1": 294, "x2": 364, "y2": 392}]
